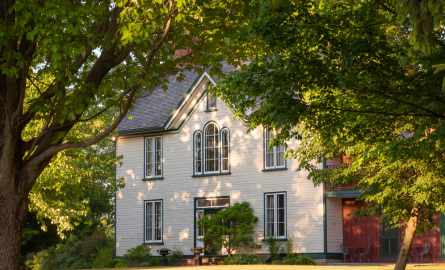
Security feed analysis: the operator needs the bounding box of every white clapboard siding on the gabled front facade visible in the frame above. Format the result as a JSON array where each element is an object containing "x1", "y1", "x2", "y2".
[{"x1": 116, "y1": 78, "x2": 324, "y2": 256}]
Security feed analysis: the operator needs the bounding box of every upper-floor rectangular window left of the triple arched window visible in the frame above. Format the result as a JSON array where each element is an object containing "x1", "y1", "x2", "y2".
[{"x1": 145, "y1": 136, "x2": 162, "y2": 178}]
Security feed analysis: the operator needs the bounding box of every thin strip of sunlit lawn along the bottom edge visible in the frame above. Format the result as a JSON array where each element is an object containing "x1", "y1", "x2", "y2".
[{"x1": 88, "y1": 265, "x2": 445, "y2": 270}]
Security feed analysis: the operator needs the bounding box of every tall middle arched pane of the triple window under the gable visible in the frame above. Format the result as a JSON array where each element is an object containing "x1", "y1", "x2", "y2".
[{"x1": 204, "y1": 124, "x2": 219, "y2": 173}]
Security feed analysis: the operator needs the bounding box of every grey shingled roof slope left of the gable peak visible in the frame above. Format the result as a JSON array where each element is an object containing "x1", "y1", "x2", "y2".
[{"x1": 118, "y1": 63, "x2": 237, "y2": 134}]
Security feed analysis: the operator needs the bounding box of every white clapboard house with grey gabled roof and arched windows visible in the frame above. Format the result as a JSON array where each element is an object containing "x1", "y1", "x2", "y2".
[{"x1": 116, "y1": 62, "x2": 343, "y2": 259}]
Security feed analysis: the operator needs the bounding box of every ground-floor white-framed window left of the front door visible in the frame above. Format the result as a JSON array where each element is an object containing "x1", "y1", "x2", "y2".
[{"x1": 145, "y1": 201, "x2": 162, "y2": 243}]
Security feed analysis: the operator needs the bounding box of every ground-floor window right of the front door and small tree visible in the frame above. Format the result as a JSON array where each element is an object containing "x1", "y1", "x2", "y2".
[{"x1": 264, "y1": 193, "x2": 286, "y2": 238}]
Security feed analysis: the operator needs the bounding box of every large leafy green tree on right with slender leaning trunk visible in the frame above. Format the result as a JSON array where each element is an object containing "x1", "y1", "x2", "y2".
[{"x1": 215, "y1": 0, "x2": 445, "y2": 269}]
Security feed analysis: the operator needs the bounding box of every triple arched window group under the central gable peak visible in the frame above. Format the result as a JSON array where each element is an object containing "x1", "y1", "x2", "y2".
[{"x1": 193, "y1": 123, "x2": 230, "y2": 176}]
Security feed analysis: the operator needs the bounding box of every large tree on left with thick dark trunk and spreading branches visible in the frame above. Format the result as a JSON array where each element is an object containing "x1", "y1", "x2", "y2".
[{"x1": 0, "y1": 0, "x2": 253, "y2": 270}]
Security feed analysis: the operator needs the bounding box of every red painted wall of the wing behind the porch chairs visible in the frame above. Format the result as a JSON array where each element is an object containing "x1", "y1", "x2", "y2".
[{"x1": 343, "y1": 199, "x2": 440, "y2": 263}]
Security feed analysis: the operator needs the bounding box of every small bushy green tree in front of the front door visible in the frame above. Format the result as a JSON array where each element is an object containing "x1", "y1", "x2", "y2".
[{"x1": 198, "y1": 202, "x2": 261, "y2": 257}]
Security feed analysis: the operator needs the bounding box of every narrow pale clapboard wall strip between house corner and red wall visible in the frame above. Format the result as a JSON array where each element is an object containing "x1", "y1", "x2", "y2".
[{"x1": 326, "y1": 198, "x2": 343, "y2": 253}]
